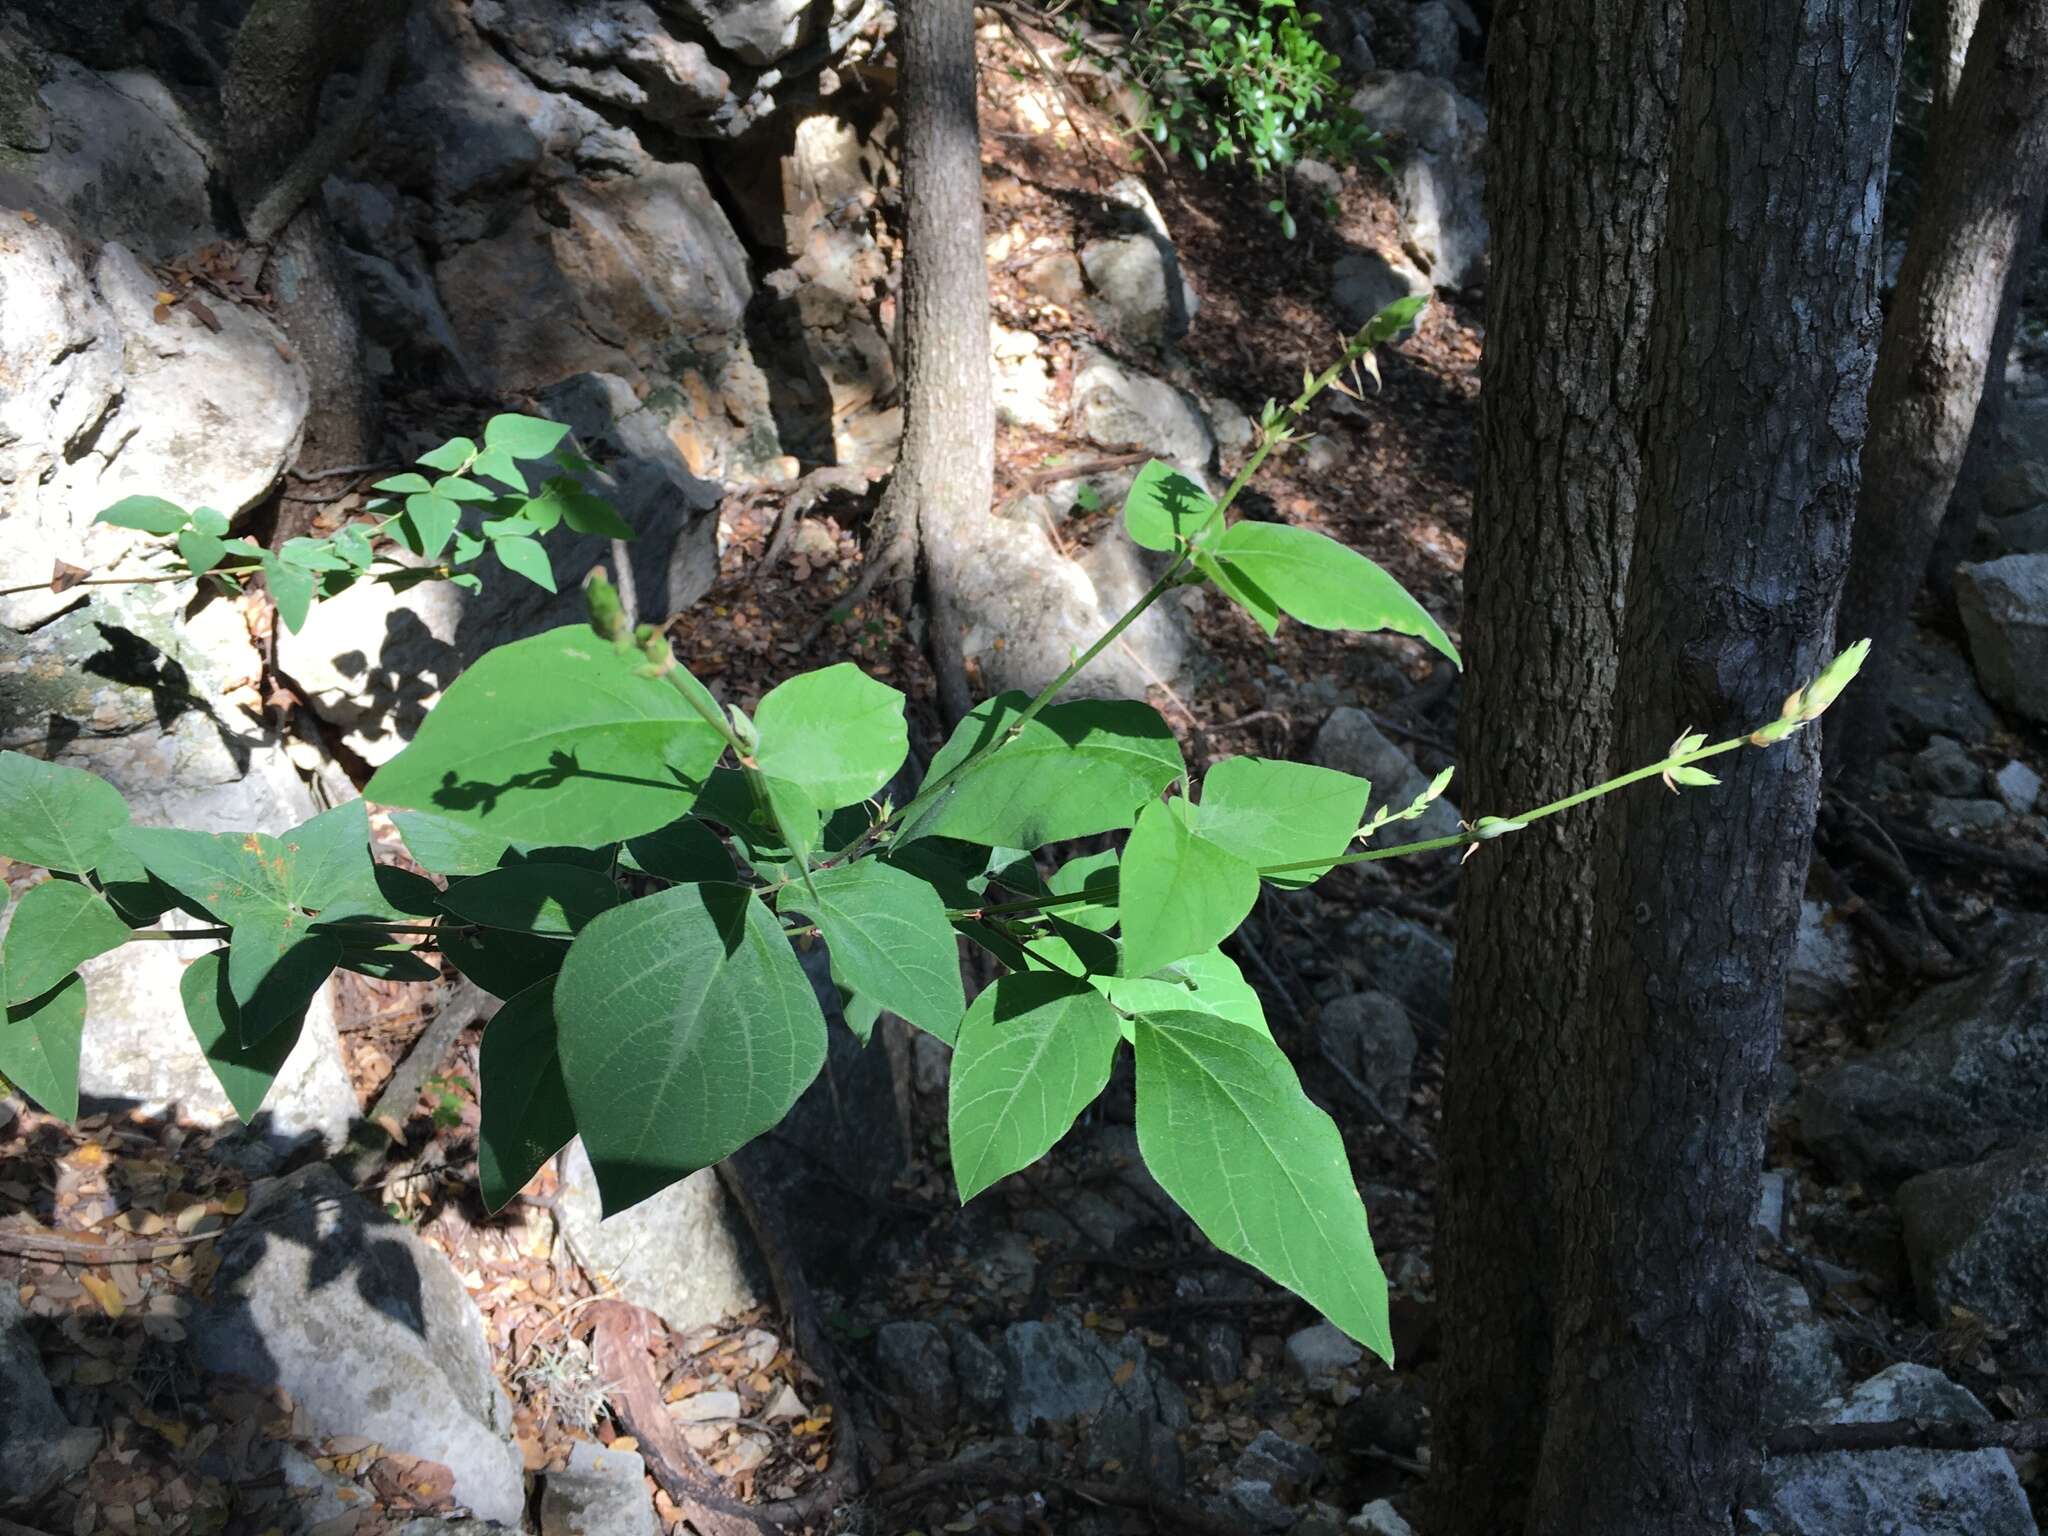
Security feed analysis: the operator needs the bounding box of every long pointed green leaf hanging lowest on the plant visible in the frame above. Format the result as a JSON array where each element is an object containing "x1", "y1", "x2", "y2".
[{"x1": 1135, "y1": 1012, "x2": 1393, "y2": 1364}]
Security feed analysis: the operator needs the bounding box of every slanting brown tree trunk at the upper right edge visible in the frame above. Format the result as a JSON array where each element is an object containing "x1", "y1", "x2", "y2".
[{"x1": 1829, "y1": 0, "x2": 2048, "y2": 778}]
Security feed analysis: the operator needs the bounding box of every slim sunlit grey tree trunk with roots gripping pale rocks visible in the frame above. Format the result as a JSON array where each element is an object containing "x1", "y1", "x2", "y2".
[{"x1": 868, "y1": 0, "x2": 995, "y2": 717}]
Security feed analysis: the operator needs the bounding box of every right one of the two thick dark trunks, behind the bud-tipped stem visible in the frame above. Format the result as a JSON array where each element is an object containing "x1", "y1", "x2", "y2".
[{"x1": 1540, "y1": 0, "x2": 1900, "y2": 1536}]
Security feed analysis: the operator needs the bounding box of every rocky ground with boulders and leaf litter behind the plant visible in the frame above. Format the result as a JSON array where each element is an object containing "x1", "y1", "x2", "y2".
[{"x1": 0, "y1": 0, "x2": 2048, "y2": 1536}]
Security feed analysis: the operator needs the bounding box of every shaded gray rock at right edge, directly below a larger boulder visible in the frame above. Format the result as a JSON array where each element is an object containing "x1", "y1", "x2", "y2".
[{"x1": 1898, "y1": 1137, "x2": 2048, "y2": 1370}]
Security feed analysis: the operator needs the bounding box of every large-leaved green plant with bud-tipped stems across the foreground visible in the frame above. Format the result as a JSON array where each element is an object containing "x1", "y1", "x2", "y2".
[{"x1": 0, "y1": 305, "x2": 1860, "y2": 1358}]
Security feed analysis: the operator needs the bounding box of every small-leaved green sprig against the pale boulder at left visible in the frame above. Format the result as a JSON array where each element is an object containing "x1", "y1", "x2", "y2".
[{"x1": 94, "y1": 414, "x2": 633, "y2": 633}]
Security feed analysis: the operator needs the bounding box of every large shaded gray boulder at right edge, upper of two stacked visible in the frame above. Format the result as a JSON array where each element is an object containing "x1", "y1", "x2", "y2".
[{"x1": 1798, "y1": 922, "x2": 2048, "y2": 1184}]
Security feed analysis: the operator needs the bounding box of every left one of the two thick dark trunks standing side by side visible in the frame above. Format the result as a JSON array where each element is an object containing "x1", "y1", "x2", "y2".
[{"x1": 1432, "y1": 0, "x2": 1681, "y2": 1536}]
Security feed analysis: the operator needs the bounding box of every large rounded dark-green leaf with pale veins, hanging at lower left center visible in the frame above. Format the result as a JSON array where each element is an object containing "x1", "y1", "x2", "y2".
[{"x1": 555, "y1": 885, "x2": 825, "y2": 1212}]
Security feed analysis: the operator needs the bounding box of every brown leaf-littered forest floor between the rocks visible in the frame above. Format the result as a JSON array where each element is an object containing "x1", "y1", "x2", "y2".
[{"x1": 0, "y1": 30, "x2": 2048, "y2": 1536}]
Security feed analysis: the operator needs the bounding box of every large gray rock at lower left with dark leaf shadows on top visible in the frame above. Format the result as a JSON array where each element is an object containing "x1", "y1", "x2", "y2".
[{"x1": 193, "y1": 1163, "x2": 526, "y2": 1526}]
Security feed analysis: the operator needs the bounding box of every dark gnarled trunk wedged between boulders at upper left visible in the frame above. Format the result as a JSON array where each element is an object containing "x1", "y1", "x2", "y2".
[{"x1": 221, "y1": 0, "x2": 403, "y2": 481}]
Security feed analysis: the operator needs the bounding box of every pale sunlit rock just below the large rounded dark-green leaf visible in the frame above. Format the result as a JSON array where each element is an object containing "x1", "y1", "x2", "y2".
[{"x1": 555, "y1": 1137, "x2": 760, "y2": 1333}]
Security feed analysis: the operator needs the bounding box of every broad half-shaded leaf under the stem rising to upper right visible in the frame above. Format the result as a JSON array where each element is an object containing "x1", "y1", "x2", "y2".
[{"x1": 913, "y1": 694, "x2": 1186, "y2": 848}]
